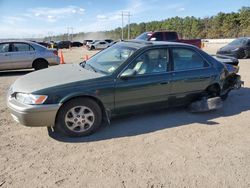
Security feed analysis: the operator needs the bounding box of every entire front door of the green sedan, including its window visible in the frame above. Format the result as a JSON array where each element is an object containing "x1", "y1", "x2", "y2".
[{"x1": 115, "y1": 49, "x2": 171, "y2": 113}]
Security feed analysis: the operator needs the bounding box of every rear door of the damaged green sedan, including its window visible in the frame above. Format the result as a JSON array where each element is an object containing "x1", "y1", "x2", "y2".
[{"x1": 171, "y1": 48, "x2": 217, "y2": 104}]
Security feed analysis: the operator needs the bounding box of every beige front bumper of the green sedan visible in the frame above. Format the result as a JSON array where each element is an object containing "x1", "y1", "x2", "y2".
[{"x1": 7, "y1": 98, "x2": 60, "y2": 127}]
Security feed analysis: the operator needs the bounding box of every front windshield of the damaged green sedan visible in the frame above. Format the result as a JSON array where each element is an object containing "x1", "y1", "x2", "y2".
[{"x1": 86, "y1": 43, "x2": 136, "y2": 74}]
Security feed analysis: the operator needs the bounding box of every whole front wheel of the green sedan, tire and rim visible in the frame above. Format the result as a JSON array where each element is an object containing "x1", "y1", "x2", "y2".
[{"x1": 55, "y1": 98, "x2": 102, "y2": 137}]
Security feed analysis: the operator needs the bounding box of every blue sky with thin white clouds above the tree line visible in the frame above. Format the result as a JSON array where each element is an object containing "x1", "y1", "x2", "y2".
[{"x1": 0, "y1": 0, "x2": 250, "y2": 38}]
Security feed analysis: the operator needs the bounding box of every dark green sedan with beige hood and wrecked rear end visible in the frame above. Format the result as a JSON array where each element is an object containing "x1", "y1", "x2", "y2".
[{"x1": 7, "y1": 41, "x2": 240, "y2": 136}]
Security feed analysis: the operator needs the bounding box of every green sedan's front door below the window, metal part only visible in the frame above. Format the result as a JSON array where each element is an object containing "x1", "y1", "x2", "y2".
[{"x1": 115, "y1": 73, "x2": 171, "y2": 109}]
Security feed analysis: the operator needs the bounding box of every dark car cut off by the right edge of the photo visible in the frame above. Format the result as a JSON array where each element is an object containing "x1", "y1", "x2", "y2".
[{"x1": 217, "y1": 37, "x2": 250, "y2": 59}]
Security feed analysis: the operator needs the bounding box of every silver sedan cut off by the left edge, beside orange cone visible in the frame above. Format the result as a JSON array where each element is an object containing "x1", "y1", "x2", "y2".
[{"x1": 0, "y1": 41, "x2": 60, "y2": 70}]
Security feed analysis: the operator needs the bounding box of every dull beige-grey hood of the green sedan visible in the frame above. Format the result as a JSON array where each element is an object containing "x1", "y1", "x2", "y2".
[{"x1": 12, "y1": 64, "x2": 104, "y2": 93}]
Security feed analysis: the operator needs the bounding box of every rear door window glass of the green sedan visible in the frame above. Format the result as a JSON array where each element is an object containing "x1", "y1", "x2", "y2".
[{"x1": 172, "y1": 48, "x2": 209, "y2": 71}]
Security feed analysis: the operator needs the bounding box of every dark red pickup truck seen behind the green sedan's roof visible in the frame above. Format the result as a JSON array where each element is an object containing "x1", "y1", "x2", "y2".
[{"x1": 135, "y1": 31, "x2": 201, "y2": 48}]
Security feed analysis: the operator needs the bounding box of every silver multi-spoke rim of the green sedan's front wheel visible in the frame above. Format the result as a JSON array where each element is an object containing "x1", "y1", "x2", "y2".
[{"x1": 65, "y1": 106, "x2": 95, "y2": 133}]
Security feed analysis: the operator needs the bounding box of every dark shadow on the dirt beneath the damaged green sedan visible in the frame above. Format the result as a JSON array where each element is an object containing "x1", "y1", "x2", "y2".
[{"x1": 48, "y1": 88, "x2": 250, "y2": 143}]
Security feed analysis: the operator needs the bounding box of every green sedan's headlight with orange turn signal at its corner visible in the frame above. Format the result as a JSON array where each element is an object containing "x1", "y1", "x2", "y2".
[{"x1": 16, "y1": 93, "x2": 48, "y2": 104}]
